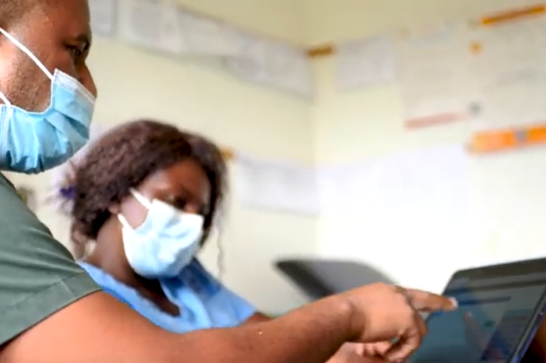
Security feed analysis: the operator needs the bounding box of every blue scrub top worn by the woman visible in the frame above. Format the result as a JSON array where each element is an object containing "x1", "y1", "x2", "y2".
[{"x1": 79, "y1": 259, "x2": 256, "y2": 333}]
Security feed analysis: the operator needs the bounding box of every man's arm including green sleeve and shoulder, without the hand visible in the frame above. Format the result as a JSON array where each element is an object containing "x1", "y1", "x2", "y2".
[{"x1": 0, "y1": 175, "x2": 349, "y2": 363}]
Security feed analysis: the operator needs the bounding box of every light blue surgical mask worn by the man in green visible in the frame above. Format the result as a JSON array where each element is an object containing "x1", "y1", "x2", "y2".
[{"x1": 0, "y1": 28, "x2": 95, "y2": 174}]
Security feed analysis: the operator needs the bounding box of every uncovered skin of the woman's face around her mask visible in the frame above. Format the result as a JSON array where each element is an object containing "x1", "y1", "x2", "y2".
[{"x1": 120, "y1": 159, "x2": 211, "y2": 228}]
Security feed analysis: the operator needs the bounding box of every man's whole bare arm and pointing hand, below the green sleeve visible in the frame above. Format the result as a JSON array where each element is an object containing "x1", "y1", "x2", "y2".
[{"x1": 0, "y1": 284, "x2": 454, "y2": 363}]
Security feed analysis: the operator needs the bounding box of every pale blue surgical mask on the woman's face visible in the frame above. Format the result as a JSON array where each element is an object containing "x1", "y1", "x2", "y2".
[{"x1": 118, "y1": 190, "x2": 204, "y2": 279}]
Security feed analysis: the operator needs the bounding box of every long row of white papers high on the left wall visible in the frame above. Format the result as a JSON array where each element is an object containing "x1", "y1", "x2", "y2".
[{"x1": 111, "y1": 0, "x2": 313, "y2": 97}]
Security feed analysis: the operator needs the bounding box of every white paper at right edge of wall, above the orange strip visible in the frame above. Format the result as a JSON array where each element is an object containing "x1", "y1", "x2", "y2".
[{"x1": 469, "y1": 10, "x2": 546, "y2": 131}]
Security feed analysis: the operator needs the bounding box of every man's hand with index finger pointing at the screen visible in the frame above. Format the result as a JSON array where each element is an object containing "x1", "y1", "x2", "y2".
[{"x1": 343, "y1": 283, "x2": 457, "y2": 361}]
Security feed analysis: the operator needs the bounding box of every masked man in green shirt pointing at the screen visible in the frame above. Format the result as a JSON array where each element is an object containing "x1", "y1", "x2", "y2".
[{"x1": 0, "y1": 0, "x2": 455, "y2": 363}]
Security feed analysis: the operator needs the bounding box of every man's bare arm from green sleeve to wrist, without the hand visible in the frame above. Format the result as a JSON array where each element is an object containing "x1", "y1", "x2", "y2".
[{"x1": 0, "y1": 292, "x2": 351, "y2": 363}]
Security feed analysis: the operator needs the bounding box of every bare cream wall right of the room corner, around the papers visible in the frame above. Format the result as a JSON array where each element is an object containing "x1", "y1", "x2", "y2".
[{"x1": 304, "y1": 0, "x2": 546, "y2": 289}]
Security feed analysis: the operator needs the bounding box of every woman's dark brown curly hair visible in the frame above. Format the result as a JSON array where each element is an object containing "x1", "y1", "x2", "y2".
[{"x1": 67, "y1": 120, "x2": 227, "y2": 255}]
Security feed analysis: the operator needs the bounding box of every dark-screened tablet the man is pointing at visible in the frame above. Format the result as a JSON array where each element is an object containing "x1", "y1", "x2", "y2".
[{"x1": 410, "y1": 258, "x2": 546, "y2": 363}]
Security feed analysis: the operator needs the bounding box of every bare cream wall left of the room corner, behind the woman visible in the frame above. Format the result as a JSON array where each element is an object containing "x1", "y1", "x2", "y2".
[{"x1": 8, "y1": 0, "x2": 316, "y2": 313}]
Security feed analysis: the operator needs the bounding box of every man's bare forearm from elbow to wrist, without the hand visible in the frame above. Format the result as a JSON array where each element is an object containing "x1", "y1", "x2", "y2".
[{"x1": 173, "y1": 298, "x2": 351, "y2": 363}]
